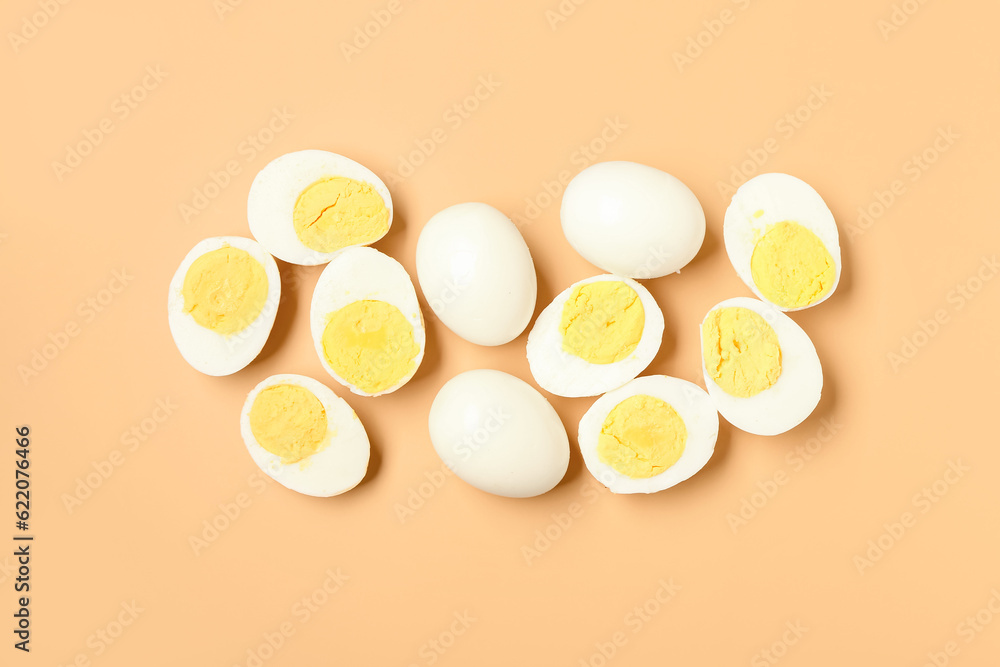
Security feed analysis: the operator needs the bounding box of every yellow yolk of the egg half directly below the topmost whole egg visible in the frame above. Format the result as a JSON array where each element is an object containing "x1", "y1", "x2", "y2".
[{"x1": 559, "y1": 280, "x2": 646, "y2": 364}]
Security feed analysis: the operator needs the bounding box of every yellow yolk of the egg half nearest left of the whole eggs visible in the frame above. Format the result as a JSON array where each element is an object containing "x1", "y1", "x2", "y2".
[{"x1": 322, "y1": 300, "x2": 420, "y2": 394}]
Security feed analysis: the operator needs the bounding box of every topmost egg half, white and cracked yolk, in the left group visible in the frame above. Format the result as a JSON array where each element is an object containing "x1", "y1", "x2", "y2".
[{"x1": 247, "y1": 150, "x2": 392, "y2": 265}]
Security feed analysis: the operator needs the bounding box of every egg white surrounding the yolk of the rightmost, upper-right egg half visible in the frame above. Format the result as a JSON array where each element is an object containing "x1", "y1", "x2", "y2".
[{"x1": 723, "y1": 174, "x2": 841, "y2": 311}]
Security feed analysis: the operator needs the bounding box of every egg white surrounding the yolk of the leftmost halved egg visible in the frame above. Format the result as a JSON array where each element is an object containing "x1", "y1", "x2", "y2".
[{"x1": 167, "y1": 236, "x2": 281, "y2": 376}]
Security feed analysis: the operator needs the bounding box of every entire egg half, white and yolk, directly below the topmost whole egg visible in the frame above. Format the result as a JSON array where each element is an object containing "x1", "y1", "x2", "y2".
[{"x1": 527, "y1": 275, "x2": 663, "y2": 397}]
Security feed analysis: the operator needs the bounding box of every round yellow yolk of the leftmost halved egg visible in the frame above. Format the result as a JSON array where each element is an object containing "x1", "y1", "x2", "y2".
[{"x1": 182, "y1": 246, "x2": 268, "y2": 336}]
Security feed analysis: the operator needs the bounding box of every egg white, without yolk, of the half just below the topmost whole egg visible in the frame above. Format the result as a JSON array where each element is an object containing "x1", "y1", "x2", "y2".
[{"x1": 527, "y1": 275, "x2": 664, "y2": 397}]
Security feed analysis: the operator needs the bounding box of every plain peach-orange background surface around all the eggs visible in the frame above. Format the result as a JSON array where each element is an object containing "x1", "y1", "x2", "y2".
[{"x1": 0, "y1": 0, "x2": 1000, "y2": 667}]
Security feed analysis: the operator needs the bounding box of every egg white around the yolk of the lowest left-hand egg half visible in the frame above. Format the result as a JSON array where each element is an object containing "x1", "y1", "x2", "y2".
[{"x1": 240, "y1": 374, "x2": 371, "y2": 498}]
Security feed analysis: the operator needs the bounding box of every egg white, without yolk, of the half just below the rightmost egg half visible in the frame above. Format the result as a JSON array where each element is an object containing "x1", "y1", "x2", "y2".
[{"x1": 698, "y1": 297, "x2": 823, "y2": 435}]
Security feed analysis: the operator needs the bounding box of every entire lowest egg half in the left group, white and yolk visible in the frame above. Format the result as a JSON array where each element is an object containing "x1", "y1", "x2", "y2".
[{"x1": 240, "y1": 375, "x2": 371, "y2": 498}]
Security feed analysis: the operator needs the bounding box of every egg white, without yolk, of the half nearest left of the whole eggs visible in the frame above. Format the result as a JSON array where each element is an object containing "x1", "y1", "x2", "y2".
[{"x1": 309, "y1": 246, "x2": 427, "y2": 396}]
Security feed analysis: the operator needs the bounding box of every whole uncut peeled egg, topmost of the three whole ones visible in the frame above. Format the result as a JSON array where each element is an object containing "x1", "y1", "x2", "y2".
[{"x1": 560, "y1": 162, "x2": 705, "y2": 279}]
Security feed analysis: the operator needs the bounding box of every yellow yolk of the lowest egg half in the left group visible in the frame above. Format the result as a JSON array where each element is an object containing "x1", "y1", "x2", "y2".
[{"x1": 250, "y1": 384, "x2": 328, "y2": 463}]
